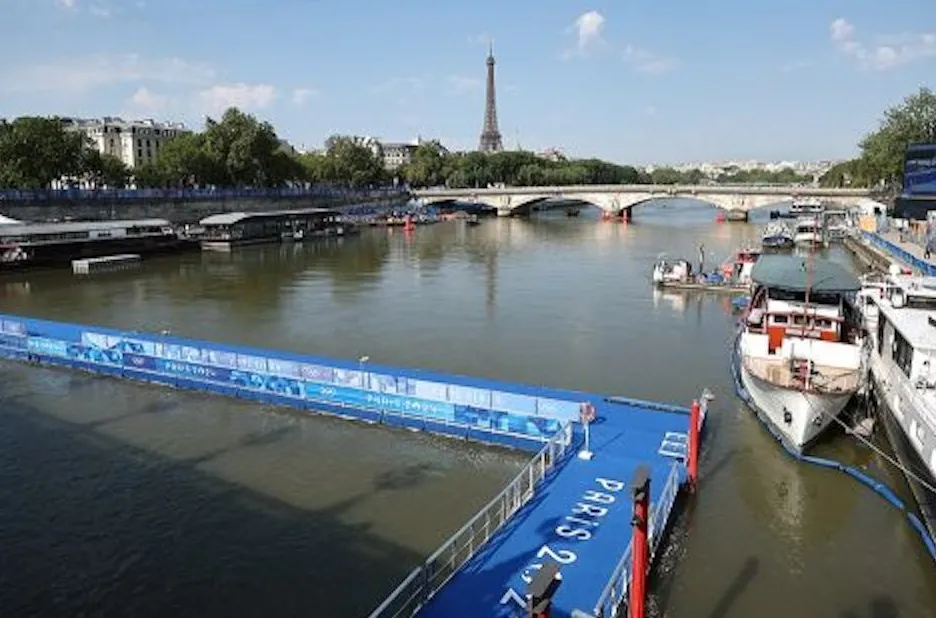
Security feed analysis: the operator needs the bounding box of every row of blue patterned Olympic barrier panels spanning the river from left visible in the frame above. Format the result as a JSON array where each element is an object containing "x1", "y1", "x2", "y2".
[{"x1": 0, "y1": 316, "x2": 579, "y2": 447}]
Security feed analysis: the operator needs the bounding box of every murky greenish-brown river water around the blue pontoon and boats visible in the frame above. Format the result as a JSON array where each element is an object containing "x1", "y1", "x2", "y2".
[{"x1": 0, "y1": 201, "x2": 936, "y2": 618}]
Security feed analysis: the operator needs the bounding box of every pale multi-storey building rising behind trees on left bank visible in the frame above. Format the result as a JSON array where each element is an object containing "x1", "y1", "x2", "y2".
[{"x1": 63, "y1": 116, "x2": 191, "y2": 168}]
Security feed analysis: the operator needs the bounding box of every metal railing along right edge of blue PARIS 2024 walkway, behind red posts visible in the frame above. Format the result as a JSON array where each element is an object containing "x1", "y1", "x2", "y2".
[{"x1": 592, "y1": 461, "x2": 683, "y2": 618}]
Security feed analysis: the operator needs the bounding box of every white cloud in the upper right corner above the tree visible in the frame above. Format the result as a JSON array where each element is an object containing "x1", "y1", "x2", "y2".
[{"x1": 829, "y1": 18, "x2": 936, "y2": 71}]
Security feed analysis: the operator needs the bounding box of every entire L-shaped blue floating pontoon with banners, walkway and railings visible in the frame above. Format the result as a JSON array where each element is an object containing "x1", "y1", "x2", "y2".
[{"x1": 0, "y1": 314, "x2": 708, "y2": 618}]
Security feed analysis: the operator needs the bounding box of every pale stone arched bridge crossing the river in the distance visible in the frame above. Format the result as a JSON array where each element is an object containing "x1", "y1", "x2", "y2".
[{"x1": 413, "y1": 185, "x2": 872, "y2": 220}]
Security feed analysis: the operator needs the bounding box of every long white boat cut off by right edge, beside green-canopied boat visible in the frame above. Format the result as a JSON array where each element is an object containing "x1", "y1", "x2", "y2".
[{"x1": 862, "y1": 267, "x2": 936, "y2": 534}]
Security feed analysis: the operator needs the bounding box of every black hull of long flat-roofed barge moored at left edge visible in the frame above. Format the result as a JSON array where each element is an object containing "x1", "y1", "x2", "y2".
[{"x1": 0, "y1": 237, "x2": 198, "y2": 273}]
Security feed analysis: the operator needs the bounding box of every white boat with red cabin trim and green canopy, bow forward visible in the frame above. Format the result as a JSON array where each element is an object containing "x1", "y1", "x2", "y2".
[{"x1": 734, "y1": 255, "x2": 862, "y2": 452}]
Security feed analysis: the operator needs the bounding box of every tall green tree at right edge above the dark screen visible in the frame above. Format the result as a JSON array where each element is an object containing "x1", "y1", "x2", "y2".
[{"x1": 860, "y1": 88, "x2": 936, "y2": 184}]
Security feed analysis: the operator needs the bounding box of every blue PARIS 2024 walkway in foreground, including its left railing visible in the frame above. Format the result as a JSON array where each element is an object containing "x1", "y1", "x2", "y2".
[{"x1": 380, "y1": 394, "x2": 704, "y2": 618}]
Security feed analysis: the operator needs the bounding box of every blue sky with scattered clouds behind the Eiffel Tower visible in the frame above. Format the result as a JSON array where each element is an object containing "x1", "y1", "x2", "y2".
[{"x1": 0, "y1": 0, "x2": 936, "y2": 165}]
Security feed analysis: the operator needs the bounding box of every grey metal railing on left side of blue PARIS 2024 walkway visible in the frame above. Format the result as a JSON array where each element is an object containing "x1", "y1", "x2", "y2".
[{"x1": 369, "y1": 422, "x2": 572, "y2": 618}]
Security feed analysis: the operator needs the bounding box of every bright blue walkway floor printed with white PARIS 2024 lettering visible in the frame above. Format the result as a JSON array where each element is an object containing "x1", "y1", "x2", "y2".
[{"x1": 416, "y1": 402, "x2": 689, "y2": 618}]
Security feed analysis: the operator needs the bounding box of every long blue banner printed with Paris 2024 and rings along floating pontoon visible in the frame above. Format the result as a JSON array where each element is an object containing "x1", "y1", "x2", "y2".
[{"x1": 9, "y1": 316, "x2": 579, "y2": 439}]
